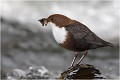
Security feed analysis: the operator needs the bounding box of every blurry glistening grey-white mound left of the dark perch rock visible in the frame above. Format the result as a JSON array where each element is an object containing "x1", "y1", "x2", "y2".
[{"x1": 7, "y1": 66, "x2": 51, "y2": 80}]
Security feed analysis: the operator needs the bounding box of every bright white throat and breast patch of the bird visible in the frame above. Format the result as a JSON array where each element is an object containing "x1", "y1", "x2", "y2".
[{"x1": 50, "y1": 23, "x2": 68, "y2": 44}]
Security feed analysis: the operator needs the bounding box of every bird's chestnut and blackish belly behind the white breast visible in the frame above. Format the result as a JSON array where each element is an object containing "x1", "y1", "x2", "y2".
[{"x1": 59, "y1": 33, "x2": 88, "y2": 52}]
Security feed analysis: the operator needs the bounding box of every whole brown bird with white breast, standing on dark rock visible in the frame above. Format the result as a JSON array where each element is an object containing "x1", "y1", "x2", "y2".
[{"x1": 38, "y1": 14, "x2": 114, "y2": 67}]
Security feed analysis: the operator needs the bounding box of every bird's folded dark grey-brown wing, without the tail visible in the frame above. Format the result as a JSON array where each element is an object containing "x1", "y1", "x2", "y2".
[{"x1": 66, "y1": 22, "x2": 102, "y2": 45}]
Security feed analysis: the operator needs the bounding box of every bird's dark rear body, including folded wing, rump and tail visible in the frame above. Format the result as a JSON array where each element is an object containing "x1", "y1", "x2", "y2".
[{"x1": 63, "y1": 21, "x2": 113, "y2": 51}]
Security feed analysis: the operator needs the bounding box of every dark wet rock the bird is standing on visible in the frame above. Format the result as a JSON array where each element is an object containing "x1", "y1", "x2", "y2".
[{"x1": 59, "y1": 64, "x2": 105, "y2": 79}]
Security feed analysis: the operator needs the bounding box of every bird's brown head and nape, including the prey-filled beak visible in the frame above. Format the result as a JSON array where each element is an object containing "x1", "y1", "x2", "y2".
[{"x1": 38, "y1": 14, "x2": 73, "y2": 27}]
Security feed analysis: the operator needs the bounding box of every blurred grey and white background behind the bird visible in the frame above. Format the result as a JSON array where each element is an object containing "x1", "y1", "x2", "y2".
[{"x1": 0, "y1": 0, "x2": 120, "y2": 79}]
